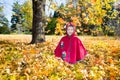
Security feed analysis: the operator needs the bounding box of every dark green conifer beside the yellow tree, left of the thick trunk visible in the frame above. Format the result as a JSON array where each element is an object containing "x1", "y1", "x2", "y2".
[{"x1": 11, "y1": 2, "x2": 25, "y2": 33}]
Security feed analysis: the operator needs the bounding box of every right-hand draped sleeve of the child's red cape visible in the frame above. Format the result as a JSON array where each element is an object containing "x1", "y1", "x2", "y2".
[{"x1": 76, "y1": 39, "x2": 87, "y2": 61}]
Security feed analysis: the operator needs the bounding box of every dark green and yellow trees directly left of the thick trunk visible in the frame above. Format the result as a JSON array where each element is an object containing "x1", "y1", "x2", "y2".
[{"x1": 11, "y1": 0, "x2": 32, "y2": 33}]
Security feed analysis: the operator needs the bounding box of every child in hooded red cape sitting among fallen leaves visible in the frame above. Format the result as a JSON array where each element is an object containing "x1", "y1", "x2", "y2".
[{"x1": 54, "y1": 22, "x2": 87, "y2": 64}]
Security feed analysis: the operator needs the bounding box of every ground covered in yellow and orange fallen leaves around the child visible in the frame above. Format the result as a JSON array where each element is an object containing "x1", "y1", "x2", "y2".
[{"x1": 0, "y1": 35, "x2": 120, "y2": 80}]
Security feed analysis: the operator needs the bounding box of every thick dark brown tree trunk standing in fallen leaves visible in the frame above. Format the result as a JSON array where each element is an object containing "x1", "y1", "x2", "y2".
[{"x1": 31, "y1": 0, "x2": 45, "y2": 44}]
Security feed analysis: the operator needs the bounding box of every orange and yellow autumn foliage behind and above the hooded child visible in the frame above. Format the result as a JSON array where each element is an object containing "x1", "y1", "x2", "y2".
[{"x1": 47, "y1": 0, "x2": 119, "y2": 35}]
